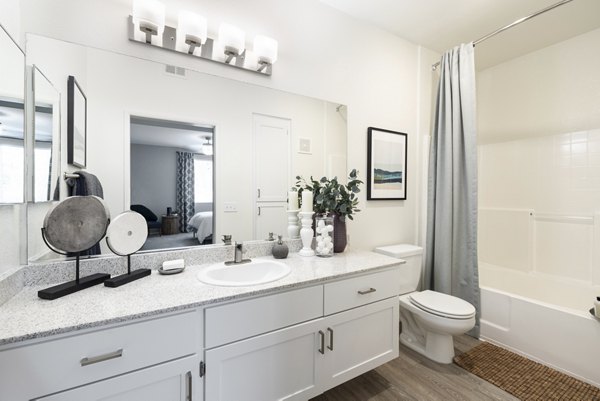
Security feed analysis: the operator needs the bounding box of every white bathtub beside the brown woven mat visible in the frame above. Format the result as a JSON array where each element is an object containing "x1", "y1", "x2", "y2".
[{"x1": 479, "y1": 263, "x2": 600, "y2": 387}]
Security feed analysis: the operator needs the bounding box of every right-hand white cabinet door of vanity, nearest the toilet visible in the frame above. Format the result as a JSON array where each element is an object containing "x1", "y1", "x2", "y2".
[{"x1": 322, "y1": 297, "x2": 399, "y2": 388}]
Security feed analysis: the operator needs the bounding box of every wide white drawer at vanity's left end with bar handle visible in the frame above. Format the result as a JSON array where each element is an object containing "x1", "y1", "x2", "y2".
[{"x1": 0, "y1": 311, "x2": 200, "y2": 400}]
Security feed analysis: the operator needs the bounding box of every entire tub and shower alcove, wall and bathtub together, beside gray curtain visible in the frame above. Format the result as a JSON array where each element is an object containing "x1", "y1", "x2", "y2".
[{"x1": 477, "y1": 29, "x2": 600, "y2": 386}]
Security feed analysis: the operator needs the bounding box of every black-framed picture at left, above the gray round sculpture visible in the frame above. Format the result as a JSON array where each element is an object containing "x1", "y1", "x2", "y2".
[{"x1": 67, "y1": 75, "x2": 87, "y2": 168}]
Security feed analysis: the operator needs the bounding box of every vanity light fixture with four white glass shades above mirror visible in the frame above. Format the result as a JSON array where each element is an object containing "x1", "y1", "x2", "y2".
[{"x1": 129, "y1": 0, "x2": 278, "y2": 75}]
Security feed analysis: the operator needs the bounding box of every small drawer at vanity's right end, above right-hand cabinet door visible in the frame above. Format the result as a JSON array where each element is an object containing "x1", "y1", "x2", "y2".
[{"x1": 324, "y1": 269, "x2": 400, "y2": 315}]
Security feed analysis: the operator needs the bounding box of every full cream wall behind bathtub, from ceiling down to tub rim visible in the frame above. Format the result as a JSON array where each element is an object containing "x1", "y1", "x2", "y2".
[{"x1": 478, "y1": 30, "x2": 600, "y2": 288}]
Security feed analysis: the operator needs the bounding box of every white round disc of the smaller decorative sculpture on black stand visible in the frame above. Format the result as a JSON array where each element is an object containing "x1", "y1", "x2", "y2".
[{"x1": 106, "y1": 211, "x2": 148, "y2": 256}]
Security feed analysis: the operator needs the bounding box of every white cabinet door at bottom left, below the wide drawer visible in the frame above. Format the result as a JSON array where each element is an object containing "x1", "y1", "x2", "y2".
[{"x1": 34, "y1": 356, "x2": 202, "y2": 401}]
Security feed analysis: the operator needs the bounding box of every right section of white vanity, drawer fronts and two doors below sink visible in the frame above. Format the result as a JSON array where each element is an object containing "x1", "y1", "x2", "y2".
[{"x1": 204, "y1": 269, "x2": 400, "y2": 401}]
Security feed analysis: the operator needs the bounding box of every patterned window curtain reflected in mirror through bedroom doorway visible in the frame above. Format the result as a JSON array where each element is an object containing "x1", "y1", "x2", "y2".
[{"x1": 176, "y1": 152, "x2": 195, "y2": 233}]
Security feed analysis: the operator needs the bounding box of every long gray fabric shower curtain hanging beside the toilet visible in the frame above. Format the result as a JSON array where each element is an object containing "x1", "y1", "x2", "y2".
[{"x1": 424, "y1": 43, "x2": 481, "y2": 337}]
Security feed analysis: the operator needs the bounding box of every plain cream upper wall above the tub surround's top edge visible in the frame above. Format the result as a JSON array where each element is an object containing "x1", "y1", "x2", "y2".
[{"x1": 477, "y1": 29, "x2": 600, "y2": 143}]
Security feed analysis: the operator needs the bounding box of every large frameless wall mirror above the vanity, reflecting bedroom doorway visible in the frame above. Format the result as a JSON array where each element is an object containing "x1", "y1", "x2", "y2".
[{"x1": 27, "y1": 34, "x2": 348, "y2": 260}]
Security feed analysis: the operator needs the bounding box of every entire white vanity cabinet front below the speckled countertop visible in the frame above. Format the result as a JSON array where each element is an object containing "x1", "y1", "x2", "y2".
[{"x1": 0, "y1": 265, "x2": 401, "y2": 401}]
